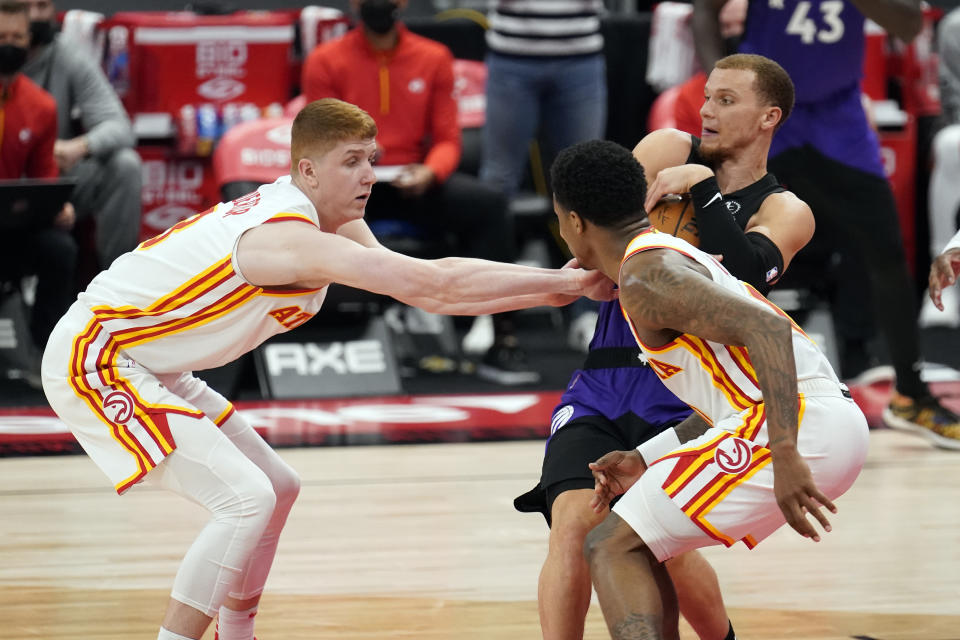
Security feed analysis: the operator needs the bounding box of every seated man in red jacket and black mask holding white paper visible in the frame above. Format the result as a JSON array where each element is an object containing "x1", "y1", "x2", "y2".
[{"x1": 302, "y1": 0, "x2": 540, "y2": 384}]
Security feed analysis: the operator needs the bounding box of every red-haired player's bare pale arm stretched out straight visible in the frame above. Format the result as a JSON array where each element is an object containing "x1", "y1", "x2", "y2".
[{"x1": 237, "y1": 222, "x2": 614, "y2": 315}]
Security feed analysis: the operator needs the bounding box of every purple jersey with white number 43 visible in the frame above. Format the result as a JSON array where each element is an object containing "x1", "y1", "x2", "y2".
[{"x1": 740, "y1": 0, "x2": 864, "y2": 103}]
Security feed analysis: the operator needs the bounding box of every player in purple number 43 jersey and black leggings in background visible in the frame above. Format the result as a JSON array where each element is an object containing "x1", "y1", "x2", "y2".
[{"x1": 693, "y1": 0, "x2": 960, "y2": 449}]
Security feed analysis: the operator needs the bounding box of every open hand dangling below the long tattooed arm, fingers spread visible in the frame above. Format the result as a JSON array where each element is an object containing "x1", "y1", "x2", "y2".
[{"x1": 773, "y1": 449, "x2": 837, "y2": 542}]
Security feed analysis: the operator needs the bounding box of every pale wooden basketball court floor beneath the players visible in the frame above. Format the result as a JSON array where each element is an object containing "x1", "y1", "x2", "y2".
[{"x1": 0, "y1": 424, "x2": 960, "y2": 640}]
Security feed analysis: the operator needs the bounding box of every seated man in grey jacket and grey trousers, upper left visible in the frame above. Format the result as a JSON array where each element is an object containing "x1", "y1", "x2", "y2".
[{"x1": 23, "y1": 0, "x2": 142, "y2": 268}]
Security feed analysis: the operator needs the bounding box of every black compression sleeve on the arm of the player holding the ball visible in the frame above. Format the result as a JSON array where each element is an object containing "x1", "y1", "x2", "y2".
[{"x1": 690, "y1": 178, "x2": 783, "y2": 293}]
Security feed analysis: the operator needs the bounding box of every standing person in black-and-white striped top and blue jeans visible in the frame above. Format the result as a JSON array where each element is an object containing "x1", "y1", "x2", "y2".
[{"x1": 480, "y1": 0, "x2": 607, "y2": 351}]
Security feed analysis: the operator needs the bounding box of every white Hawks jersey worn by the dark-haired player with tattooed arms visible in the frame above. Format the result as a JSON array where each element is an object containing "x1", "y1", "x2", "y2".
[{"x1": 621, "y1": 229, "x2": 839, "y2": 424}]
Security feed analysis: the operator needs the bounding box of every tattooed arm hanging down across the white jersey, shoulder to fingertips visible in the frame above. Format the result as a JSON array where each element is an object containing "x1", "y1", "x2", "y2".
[{"x1": 620, "y1": 249, "x2": 836, "y2": 541}]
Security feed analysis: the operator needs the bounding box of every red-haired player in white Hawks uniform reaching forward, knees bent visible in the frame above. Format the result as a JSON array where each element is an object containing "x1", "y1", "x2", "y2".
[{"x1": 42, "y1": 99, "x2": 612, "y2": 640}]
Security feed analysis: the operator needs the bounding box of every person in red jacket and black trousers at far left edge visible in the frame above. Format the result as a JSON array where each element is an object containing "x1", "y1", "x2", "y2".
[{"x1": 0, "y1": 1, "x2": 77, "y2": 356}]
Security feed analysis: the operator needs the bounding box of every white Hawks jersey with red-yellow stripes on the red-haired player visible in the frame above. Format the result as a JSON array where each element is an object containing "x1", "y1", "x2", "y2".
[{"x1": 78, "y1": 176, "x2": 326, "y2": 373}]
